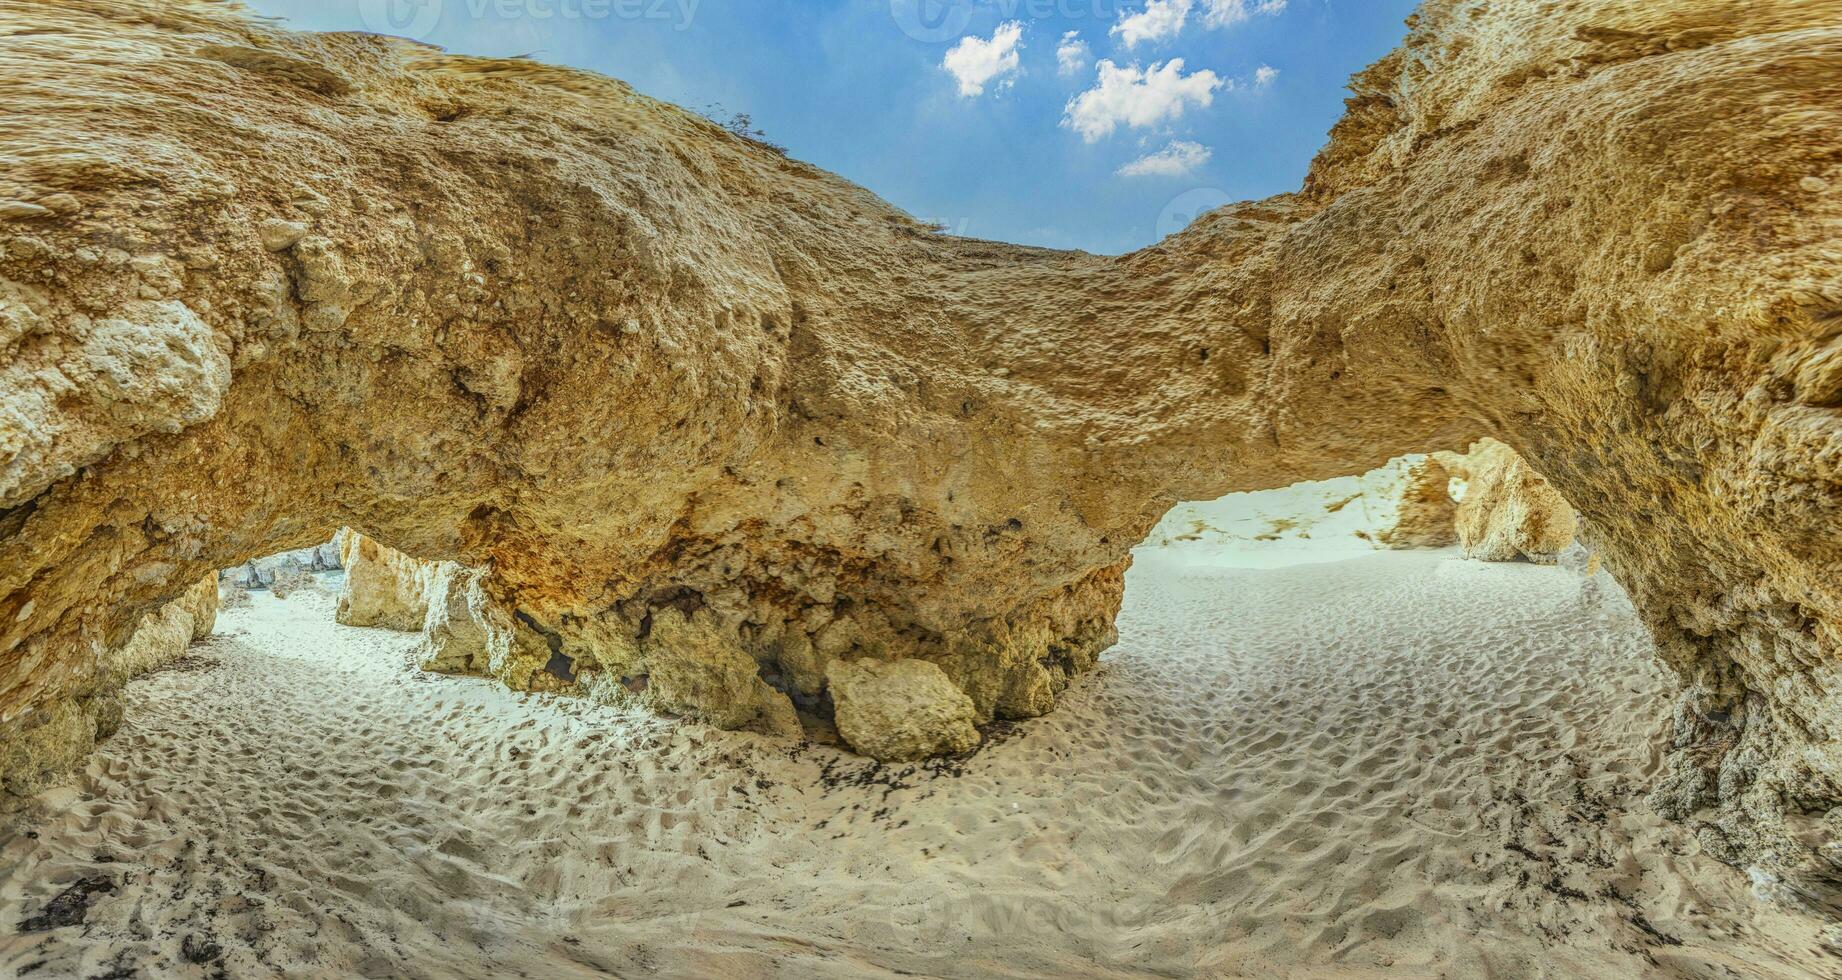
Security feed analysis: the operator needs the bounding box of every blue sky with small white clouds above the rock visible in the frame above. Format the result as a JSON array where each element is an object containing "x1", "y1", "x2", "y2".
[{"x1": 245, "y1": 0, "x2": 1415, "y2": 252}]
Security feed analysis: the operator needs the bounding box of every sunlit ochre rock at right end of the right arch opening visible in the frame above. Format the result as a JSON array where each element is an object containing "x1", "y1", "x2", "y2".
[{"x1": 1439, "y1": 438, "x2": 1579, "y2": 566}]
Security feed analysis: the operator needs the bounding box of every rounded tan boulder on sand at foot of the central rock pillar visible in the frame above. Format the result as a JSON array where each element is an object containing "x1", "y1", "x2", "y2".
[{"x1": 825, "y1": 659, "x2": 980, "y2": 763}]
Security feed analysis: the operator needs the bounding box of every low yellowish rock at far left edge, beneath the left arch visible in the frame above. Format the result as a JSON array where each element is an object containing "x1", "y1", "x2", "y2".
[{"x1": 0, "y1": 573, "x2": 217, "y2": 814}]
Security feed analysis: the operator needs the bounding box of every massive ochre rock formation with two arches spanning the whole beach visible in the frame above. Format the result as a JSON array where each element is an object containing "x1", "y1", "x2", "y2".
[{"x1": 0, "y1": 0, "x2": 1842, "y2": 858}]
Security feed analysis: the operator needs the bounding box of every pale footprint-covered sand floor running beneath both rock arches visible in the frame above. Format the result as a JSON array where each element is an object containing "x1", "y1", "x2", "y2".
[{"x1": 0, "y1": 540, "x2": 1842, "y2": 978}]
